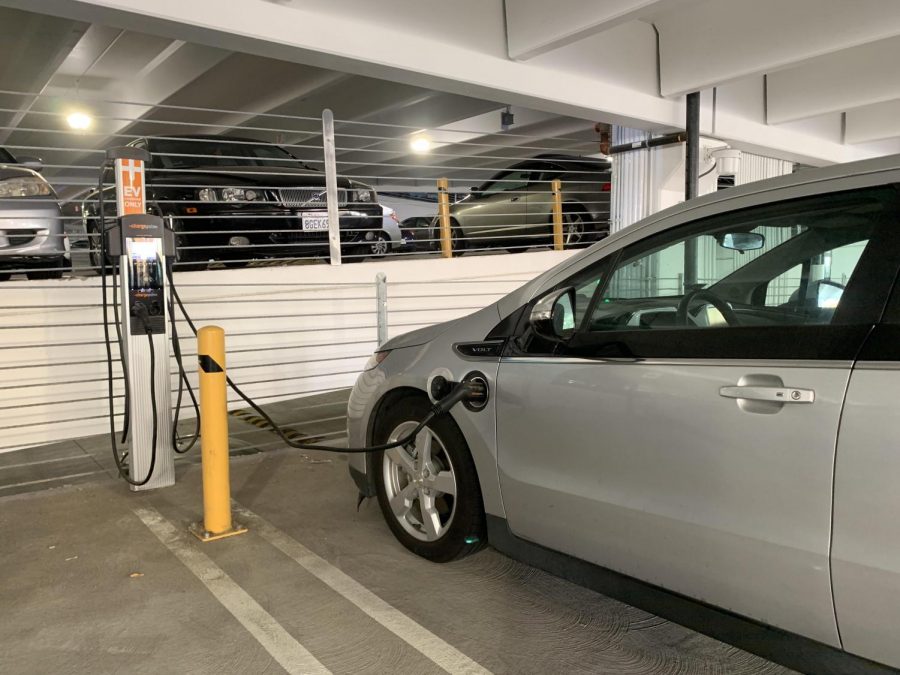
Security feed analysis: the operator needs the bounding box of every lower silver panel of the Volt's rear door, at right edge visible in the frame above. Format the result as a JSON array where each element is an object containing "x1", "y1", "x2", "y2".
[{"x1": 831, "y1": 362, "x2": 900, "y2": 667}]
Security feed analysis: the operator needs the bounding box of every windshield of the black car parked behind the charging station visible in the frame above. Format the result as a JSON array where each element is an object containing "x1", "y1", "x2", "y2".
[{"x1": 150, "y1": 139, "x2": 314, "y2": 170}]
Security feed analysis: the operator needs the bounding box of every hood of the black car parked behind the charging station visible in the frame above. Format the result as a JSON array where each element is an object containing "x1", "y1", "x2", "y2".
[{"x1": 147, "y1": 166, "x2": 369, "y2": 189}]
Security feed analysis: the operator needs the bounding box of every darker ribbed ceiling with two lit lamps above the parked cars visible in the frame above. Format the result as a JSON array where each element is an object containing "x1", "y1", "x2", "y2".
[{"x1": 0, "y1": 8, "x2": 597, "y2": 194}]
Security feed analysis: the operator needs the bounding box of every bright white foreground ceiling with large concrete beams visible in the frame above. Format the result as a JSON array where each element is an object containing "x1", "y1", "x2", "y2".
[{"x1": 10, "y1": 0, "x2": 900, "y2": 164}]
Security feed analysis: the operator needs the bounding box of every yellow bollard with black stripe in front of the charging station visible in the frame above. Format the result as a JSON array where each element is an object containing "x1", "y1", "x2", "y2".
[{"x1": 190, "y1": 326, "x2": 247, "y2": 541}]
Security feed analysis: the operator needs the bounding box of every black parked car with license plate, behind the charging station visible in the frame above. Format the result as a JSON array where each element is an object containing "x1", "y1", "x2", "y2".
[{"x1": 82, "y1": 136, "x2": 382, "y2": 267}]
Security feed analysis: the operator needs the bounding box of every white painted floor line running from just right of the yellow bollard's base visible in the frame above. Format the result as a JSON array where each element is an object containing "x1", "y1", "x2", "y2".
[{"x1": 233, "y1": 502, "x2": 490, "y2": 675}]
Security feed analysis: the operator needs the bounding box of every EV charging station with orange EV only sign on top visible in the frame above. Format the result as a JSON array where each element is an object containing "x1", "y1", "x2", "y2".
[{"x1": 104, "y1": 147, "x2": 175, "y2": 490}]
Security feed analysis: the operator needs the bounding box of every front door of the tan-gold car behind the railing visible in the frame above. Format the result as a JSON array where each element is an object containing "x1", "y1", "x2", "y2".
[{"x1": 459, "y1": 169, "x2": 532, "y2": 245}]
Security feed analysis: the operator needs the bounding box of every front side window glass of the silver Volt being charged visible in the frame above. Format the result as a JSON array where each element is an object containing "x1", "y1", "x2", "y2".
[{"x1": 586, "y1": 193, "x2": 882, "y2": 331}]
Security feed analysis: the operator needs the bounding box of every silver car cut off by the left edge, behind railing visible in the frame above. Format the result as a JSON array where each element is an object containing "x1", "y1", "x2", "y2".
[{"x1": 0, "y1": 148, "x2": 68, "y2": 281}]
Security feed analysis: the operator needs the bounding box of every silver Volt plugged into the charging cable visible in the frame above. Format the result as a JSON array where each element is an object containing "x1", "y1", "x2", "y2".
[{"x1": 348, "y1": 156, "x2": 900, "y2": 672}]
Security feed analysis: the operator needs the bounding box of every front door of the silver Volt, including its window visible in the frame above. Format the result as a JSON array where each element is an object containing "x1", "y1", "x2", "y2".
[{"x1": 496, "y1": 189, "x2": 897, "y2": 645}]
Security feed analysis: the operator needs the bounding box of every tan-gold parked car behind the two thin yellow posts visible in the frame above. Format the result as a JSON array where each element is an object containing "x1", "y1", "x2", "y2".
[{"x1": 429, "y1": 155, "x2": 611, "y2": 252}]
